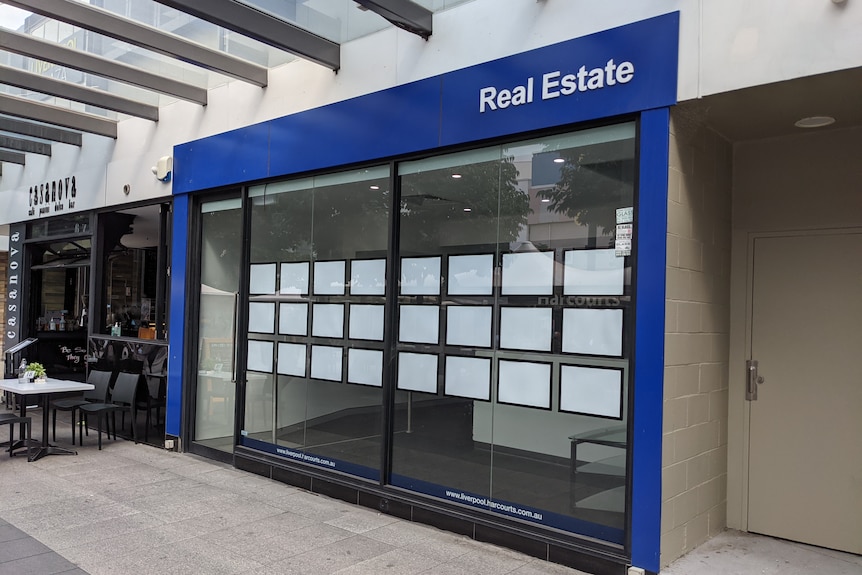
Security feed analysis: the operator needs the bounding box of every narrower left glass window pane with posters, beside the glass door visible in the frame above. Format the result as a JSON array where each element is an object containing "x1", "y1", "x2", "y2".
[{"x1": 243, "y1": 167, "x2": 392, "y2": 479}]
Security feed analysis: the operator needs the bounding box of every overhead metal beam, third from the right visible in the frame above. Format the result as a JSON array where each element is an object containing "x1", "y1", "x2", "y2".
[{"x1": 3, "y1": 0, "x2": 267, "y2": 87}]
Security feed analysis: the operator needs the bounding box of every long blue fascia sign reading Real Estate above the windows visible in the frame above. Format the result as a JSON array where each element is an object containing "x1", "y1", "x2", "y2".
[{"x1": 173, "y1": 12, "x2": 679, "y2": 194}]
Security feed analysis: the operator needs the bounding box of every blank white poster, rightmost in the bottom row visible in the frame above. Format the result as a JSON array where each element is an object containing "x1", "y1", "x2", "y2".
[{"x1": 560, "y1": 365, "x2": 623, "y2": 419}]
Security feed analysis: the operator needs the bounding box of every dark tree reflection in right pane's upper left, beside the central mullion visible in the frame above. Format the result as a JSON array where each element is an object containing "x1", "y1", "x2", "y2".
[{"x1": 401, "y1": 158, "x2": 530, "y2": 253}]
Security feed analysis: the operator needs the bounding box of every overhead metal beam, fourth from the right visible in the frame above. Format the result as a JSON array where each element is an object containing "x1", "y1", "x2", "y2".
[{"x1": 0, "y1": 28, "x2": 207, "y2": 106}]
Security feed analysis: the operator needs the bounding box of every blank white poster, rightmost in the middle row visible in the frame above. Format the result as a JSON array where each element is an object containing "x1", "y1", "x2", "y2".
[{"x1": 563, "y1": 309, "x2": 623, "y2": 357}]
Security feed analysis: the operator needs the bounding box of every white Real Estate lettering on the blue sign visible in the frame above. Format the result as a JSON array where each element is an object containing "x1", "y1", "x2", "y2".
[{"x1": 479, "y1": 59, "x2": 635, "y2": 113}]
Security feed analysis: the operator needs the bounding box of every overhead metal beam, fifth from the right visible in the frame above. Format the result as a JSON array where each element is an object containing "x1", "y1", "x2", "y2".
[{"x1": 0, "y1": 65, "x2": 159, "y2": 122}]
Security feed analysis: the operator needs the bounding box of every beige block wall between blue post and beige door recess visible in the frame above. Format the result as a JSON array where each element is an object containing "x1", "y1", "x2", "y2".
[{"x1": 661, "y1": 105, "x2": 732, "y2": 565}]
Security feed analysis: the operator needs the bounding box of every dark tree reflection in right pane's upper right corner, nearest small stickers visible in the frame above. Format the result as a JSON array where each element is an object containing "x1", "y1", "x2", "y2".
[{"x1": 537, "y1": 140, "x2": 634, "y2": 246}]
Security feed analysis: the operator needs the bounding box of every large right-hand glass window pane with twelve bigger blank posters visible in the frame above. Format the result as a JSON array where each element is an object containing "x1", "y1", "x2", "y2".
[{"x1": 392, "y1": 124, "x2": 635, "y2": 543}]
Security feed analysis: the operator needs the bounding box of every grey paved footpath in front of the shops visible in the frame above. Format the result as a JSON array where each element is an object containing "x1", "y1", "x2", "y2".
[{"x1": 0, "y1": 411, "x2": 862, "y2": 575}]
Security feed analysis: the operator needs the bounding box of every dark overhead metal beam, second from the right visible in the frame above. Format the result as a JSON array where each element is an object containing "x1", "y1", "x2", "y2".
[{"x1": 156, "y1": 0, "x2": 341, "y2": 70}]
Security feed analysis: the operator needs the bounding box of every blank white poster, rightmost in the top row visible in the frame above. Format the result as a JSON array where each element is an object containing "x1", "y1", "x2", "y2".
[{"x1": 563, "y1": 250, "x2": 625, "y2": 295}]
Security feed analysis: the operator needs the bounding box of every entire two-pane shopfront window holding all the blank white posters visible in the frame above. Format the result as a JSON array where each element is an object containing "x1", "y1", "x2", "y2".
[{"x1": 236, "y1": 122, "x2": 636, "y2": 545}]
